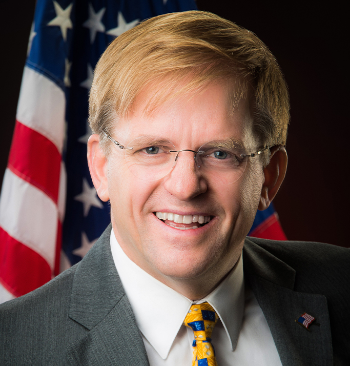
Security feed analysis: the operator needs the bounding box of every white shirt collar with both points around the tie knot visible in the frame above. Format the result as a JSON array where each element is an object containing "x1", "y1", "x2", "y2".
[{"x1": 110, "y1": 230, "x2": 244, "y2": 359}]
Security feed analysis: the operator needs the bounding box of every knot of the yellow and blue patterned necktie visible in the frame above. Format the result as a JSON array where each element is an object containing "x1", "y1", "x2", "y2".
[{"x1": 184, "y1": 302, "x2": 219, "y2": 342}]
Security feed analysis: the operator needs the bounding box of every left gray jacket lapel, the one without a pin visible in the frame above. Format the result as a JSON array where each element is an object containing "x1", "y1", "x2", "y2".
[{"x1": 67, "y1": 226, "x2": 149, "y2": 366}]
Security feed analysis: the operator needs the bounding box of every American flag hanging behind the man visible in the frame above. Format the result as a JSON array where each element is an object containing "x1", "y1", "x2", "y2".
[{"x1": 0, "y1": 0, "x2": 283, "y2": 302}]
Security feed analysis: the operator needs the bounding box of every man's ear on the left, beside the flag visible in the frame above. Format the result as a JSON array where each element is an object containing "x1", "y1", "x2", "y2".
[{"x1": 87, "y1": 134, "x2": 109, "y2": 202}]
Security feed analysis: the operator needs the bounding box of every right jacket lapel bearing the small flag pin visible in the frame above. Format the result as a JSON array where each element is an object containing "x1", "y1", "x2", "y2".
[{"x1": 243, "y1": 239, "x2": 333, "y2": 366}]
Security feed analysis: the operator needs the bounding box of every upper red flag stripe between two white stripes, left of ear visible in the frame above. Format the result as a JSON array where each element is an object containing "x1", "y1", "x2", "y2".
[{"x1": 8, "y1": 121, "x2": 61, "y2": 204}]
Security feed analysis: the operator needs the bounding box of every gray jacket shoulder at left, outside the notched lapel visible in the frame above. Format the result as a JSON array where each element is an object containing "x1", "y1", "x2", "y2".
[{"x1": 0, "y1": 266, "x2": 86, "y2": 365}]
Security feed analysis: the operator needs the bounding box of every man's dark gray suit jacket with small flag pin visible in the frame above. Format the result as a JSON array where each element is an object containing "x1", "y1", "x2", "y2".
[{"x1": 0, "y1": 227, "x2": 350, "y2": 366}]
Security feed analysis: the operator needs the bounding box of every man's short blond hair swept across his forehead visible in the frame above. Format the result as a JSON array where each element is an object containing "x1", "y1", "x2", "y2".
[{"x1": 89, "y1": 11, "x2": 289, "y2": 153}]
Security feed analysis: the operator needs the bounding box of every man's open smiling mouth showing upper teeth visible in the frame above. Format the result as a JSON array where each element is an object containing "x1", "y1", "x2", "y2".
[{"x1": 154, "y1": 211, "x2": 212, "y2": 230}]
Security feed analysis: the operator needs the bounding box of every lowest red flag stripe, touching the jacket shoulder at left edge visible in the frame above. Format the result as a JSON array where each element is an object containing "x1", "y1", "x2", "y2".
[{"x1": 0, "y1": 227, "x2": 51, "y2": 297}]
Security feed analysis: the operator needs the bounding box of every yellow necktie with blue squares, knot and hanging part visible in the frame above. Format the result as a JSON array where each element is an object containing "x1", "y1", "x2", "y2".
[{"x1": 184, "y1": 302, "x2": 219, "y2": 366}]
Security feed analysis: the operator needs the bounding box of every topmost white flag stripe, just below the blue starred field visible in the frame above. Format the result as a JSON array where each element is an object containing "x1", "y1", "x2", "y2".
[{"x1": 17, "y1": 66, "x2": 66, "y2": 153}]
